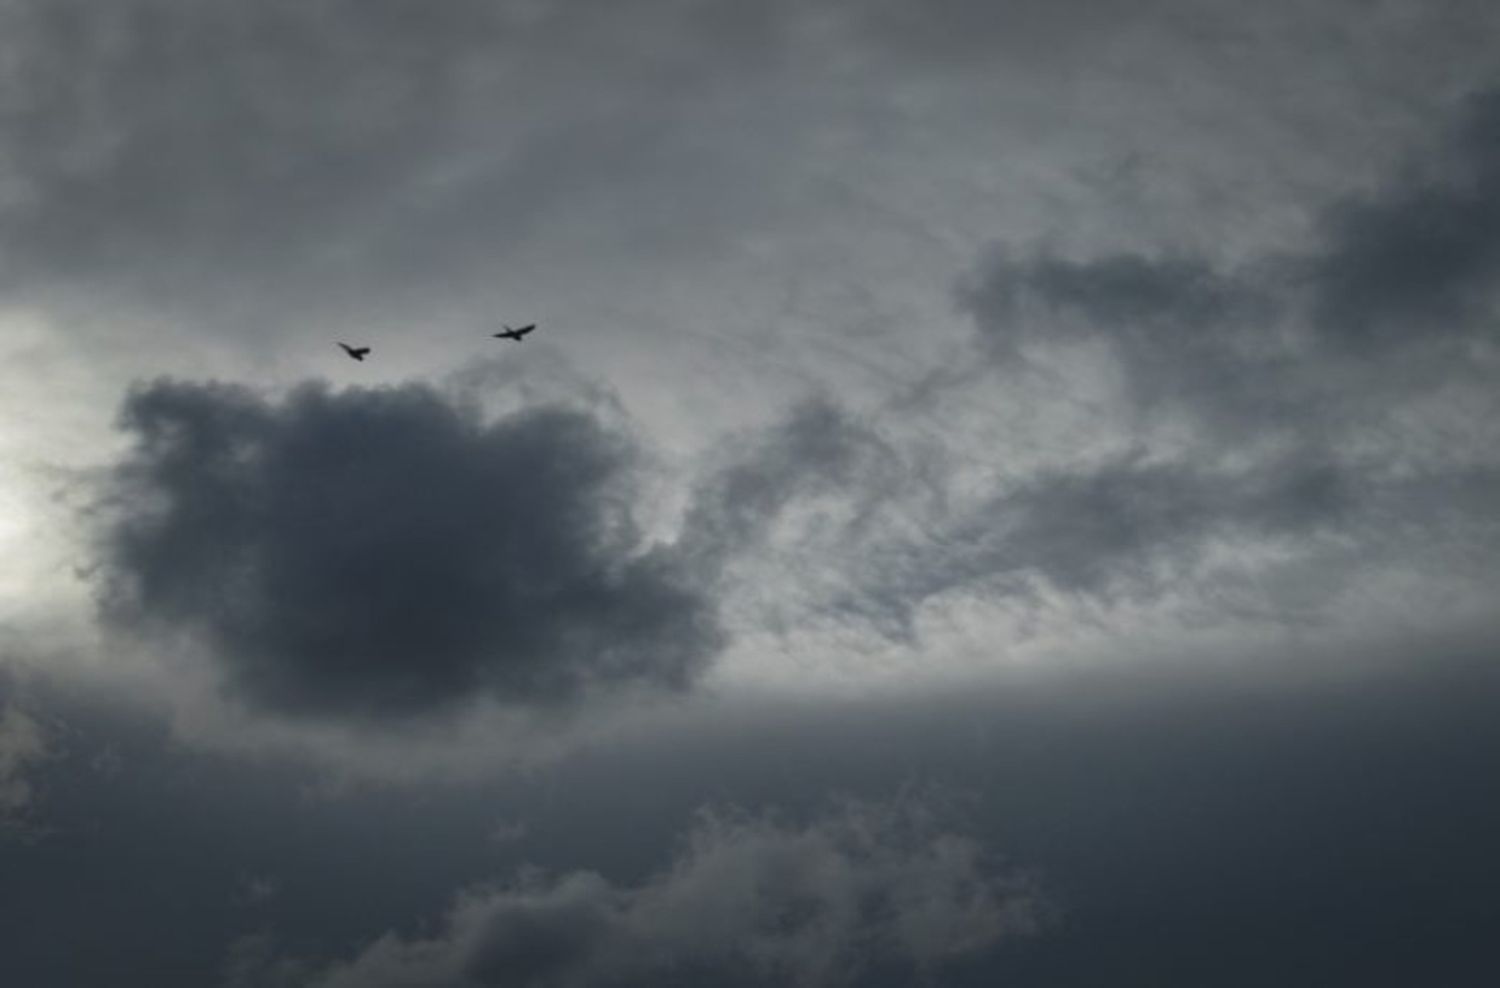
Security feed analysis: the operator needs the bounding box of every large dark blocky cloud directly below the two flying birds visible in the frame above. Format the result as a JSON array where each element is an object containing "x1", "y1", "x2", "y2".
[{"x1": 102, "y1": 381, "x2": 722, "y2": 717}]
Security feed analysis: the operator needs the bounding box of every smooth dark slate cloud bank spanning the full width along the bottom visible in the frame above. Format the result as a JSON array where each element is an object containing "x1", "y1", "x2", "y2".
[{"x1": 0, "y1": 621, "x2": 1500, "y2": 988}]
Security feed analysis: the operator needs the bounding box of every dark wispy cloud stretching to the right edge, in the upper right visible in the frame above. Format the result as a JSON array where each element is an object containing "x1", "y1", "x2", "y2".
[{"x1": 959, "y1": 83, "x2": 1500, "y2": 410}]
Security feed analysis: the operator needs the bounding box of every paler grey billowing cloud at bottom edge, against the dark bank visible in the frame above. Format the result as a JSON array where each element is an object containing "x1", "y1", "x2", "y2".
[{"x1": 276, "y1": 804, "x2": 1046, "y2": 988}]
